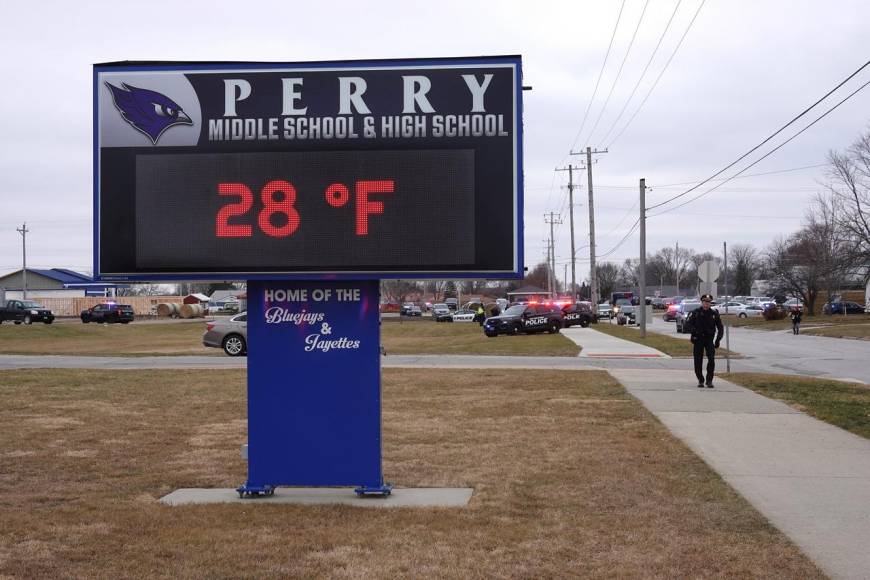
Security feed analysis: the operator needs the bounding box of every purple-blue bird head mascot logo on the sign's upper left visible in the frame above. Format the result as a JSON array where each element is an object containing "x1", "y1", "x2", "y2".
[{"x1": 106, "y1": 83, "x2": 193, "y2": 145}]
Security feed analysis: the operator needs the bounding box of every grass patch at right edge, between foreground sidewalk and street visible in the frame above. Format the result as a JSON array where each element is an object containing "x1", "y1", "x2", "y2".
[{"x1": 725, "y1": 373, "x2": 870, "y2": 439}]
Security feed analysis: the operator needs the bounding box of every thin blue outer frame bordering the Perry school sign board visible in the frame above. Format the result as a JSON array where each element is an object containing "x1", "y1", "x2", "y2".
[{"x1": 93, "y1": 56, "x2": 524, "y2": 281}]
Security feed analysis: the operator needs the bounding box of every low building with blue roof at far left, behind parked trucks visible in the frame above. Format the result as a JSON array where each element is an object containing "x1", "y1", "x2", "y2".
[{"x1": 0, "y1": 268, "x2": 130, "y2": 300}]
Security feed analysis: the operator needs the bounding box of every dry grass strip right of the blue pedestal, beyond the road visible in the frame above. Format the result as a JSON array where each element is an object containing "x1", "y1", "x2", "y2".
[{"x1": 381, "y1": 317, "x2": 580, "y2": 356}]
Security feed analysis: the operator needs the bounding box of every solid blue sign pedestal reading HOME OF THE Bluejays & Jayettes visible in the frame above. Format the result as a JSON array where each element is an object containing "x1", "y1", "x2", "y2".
[{"x1": 237, "y1": 280, "x2": 391, "y2": 496}]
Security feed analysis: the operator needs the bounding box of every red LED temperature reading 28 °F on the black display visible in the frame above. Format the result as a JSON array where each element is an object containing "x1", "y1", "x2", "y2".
[{"x1": 215, "y1": 179, "x2": 396, "y2": 238}]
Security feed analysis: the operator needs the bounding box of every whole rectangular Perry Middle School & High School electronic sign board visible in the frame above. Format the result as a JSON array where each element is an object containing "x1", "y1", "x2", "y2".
[{"x1": 94, "y1": 57, "x2": 523, "y2": 280}]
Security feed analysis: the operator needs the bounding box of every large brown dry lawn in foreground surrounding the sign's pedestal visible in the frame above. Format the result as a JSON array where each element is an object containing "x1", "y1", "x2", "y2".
[{"x1": 0, "y1": 369, "x2": 821, "y2": 578}]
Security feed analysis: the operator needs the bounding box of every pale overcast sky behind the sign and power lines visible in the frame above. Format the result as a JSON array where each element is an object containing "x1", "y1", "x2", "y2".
[{"x1": 0, "y1": 0, "x2": 870, "y2": 282}]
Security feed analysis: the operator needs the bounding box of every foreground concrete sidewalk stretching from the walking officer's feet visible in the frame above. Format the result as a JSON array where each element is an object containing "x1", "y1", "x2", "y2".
[{"x1": 610, "y1": 369, "x2": 870, "y2": 578}]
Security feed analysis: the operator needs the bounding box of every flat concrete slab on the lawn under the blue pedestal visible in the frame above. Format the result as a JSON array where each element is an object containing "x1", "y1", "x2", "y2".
[{"x1": 160, "y1": 487, "x2": 474, "y2": 508}]
